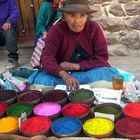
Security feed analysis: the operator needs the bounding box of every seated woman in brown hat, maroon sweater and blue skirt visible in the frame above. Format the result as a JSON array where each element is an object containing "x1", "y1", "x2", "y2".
[{"x1": 28, "y1": 0, "x2": 136, "y2": 90}]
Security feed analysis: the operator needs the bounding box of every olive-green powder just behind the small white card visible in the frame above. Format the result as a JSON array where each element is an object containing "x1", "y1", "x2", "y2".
[{"x1": 95, "y1": 105, "x2": 121, "y2": 115}]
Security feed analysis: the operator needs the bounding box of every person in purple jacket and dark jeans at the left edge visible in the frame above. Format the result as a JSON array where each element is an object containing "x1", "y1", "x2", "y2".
[{"x1": 0, "y1": 0, "x2": 19, "y2": 69}]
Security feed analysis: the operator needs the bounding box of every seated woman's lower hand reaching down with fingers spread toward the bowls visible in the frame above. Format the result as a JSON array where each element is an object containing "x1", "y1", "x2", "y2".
[{"x1": 59, "y1": 70, "x2": 79, "y2": 91}]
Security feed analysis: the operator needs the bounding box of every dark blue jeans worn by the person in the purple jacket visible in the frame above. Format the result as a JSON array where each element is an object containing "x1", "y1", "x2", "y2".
[{"x1": 0, "y1": 26, "x2": 18, "y2": 61}]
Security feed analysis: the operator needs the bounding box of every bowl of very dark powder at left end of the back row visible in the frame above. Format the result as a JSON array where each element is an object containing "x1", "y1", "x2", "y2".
[{"x1": 0, "y1": 90, "x2": 17, "y2": 105}]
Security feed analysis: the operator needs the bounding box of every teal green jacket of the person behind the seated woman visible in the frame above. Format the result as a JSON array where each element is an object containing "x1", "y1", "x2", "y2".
[{"x1": 36, "y1": 2, "x2": 61, "y2": 35}]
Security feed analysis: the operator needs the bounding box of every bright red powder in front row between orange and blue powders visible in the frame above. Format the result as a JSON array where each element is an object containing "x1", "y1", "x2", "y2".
[{"x1": 21, "y1": 116, "x2": 52, "y2": 134}]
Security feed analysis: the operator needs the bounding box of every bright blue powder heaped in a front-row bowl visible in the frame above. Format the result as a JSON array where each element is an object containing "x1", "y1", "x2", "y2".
[{"x1": 51, "y1": 117, "x2": 82, "y2": 135}]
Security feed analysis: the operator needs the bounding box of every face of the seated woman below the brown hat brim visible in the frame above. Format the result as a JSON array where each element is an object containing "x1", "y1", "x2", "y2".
[{"x1": 64, "y1": 13, "x2": 88, "y2": 33}]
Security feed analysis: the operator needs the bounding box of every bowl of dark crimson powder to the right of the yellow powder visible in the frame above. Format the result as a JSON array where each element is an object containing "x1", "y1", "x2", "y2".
[{"x1": 115, "y1": 118, "x2": 140, "y2": 139}]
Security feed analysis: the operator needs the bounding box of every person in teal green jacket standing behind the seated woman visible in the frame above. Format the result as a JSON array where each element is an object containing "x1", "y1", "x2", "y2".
[{"x1": 36, "y1": 0, "x2": 61, "y2": 39}]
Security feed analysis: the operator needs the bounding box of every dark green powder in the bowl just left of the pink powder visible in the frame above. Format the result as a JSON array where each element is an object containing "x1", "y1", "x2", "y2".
[{"x1": 6, "y1": 103, "x2": 33, "y2": 117}]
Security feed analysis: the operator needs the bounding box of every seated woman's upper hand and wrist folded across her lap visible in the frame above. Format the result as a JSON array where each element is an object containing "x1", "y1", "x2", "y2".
[{"x1": 60, "y1": 61, "x2": 80, "y2": 71}]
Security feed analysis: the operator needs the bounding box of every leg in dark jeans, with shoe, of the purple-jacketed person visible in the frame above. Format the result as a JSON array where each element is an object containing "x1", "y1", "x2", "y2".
[{"x1": 4, "y1": 27, "x2": 18, "y2": 69}]
